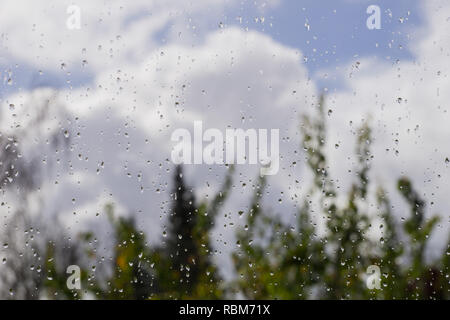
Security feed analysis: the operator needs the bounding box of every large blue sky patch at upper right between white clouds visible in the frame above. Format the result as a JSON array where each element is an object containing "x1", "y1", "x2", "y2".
[{"x1": 227, "y1": 0, "x2": 424, "y2": 90}]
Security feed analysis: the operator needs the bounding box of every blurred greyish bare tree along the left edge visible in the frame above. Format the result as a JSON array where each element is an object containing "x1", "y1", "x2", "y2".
[{"x1": 0, "y1": 94, "x2": 80, "y2": 299}]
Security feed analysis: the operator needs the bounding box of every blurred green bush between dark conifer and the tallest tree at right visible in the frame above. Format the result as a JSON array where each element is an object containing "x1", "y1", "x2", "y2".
[{"x1": 233, "y1": 178, "x2": 326, "y2": 299}]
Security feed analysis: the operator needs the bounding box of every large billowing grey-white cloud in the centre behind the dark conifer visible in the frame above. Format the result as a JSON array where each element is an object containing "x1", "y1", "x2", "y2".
[{"x1": 3, "y1": 21, "x2": 316, "y2": 276}]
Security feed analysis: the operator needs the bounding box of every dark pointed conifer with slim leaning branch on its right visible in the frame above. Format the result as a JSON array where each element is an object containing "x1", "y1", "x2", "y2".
[{"x1": 152, "y1": 166, "x2": 233, "y2": 299}]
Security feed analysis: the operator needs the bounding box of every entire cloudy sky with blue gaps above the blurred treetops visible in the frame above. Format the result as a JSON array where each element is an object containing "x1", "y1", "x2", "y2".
[{"x1": 0, "y1": 0, "x2": 450, "y2": 278}]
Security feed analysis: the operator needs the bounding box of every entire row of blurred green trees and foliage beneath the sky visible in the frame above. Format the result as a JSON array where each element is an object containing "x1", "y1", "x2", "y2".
[{"x1": 0, "y1": 97, "x2": 450, "y2": 299}]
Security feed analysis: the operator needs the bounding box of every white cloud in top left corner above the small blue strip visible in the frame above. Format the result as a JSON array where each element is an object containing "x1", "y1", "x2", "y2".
[{"x1": 0, "y1": 0, "x2": 239, "y2": 72}]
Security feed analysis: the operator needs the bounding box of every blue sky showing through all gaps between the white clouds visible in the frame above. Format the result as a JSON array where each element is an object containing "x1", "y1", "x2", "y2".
[{"x1": 0, "y1": 0, "x2": 424, "y2": 96}]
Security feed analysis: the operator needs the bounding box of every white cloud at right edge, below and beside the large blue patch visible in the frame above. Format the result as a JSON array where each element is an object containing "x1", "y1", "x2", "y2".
[{"x1": 320, "y1": 1, "x2": 450, "y2": 256}]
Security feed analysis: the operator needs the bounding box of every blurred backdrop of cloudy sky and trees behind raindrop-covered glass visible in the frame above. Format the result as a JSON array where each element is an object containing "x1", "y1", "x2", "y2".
[{"x1": 0, "y1": 0, "x2": 450, "y2": 299}]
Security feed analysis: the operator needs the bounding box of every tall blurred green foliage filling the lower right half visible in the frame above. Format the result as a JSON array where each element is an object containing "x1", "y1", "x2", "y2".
[{"x1": 233, "y1": 98, "x2": 449, "y2": 299}]
